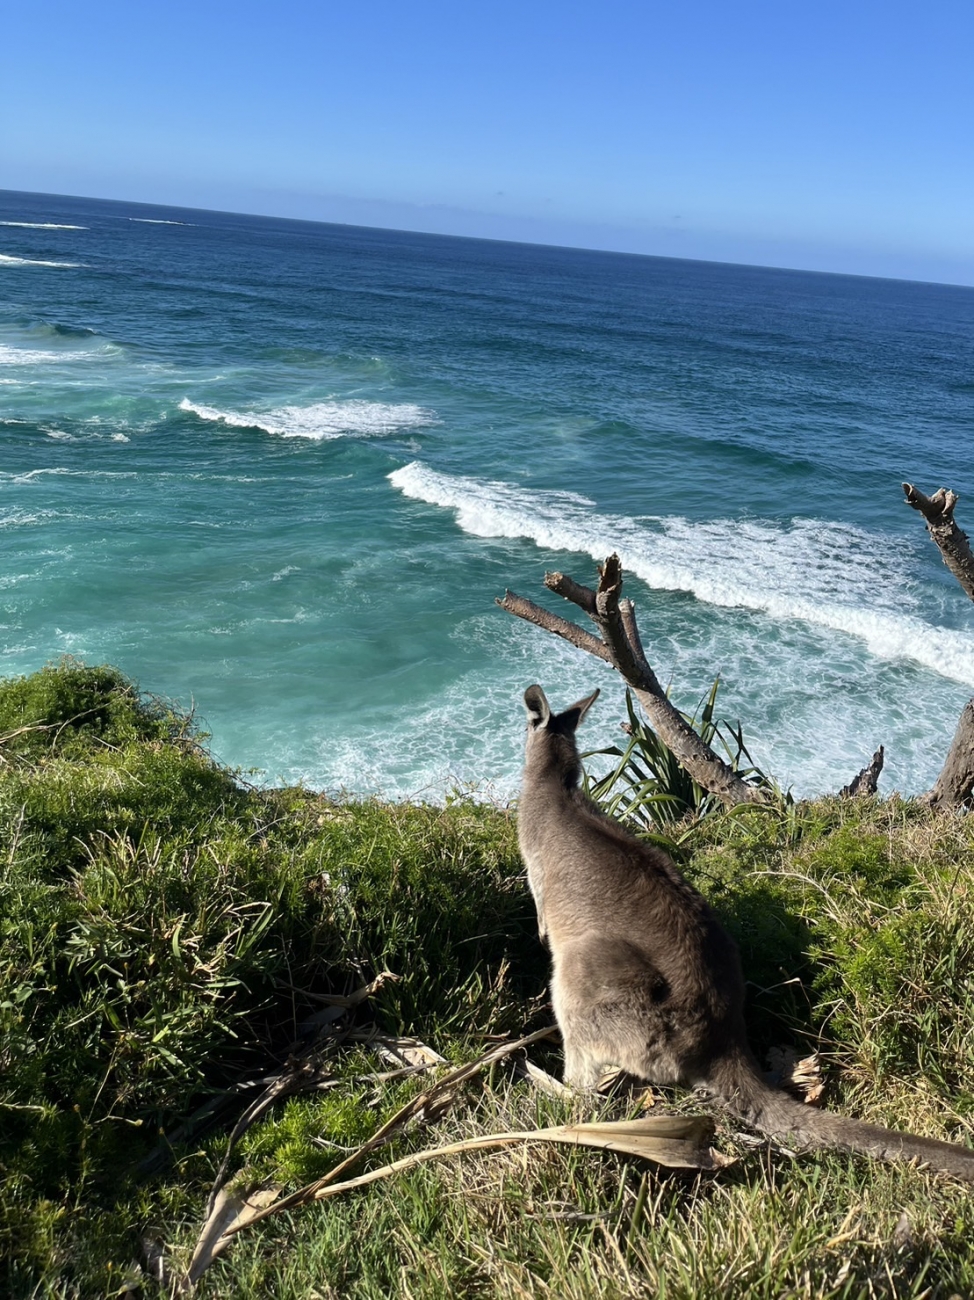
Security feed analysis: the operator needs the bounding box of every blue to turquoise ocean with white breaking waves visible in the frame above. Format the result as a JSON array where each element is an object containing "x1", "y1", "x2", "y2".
[{"x1": 0, "y1": 192, "x2": 974, "y2": 797}]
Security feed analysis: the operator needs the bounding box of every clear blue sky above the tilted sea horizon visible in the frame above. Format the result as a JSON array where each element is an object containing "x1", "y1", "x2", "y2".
[{"x1": 0, "y1": 0, "x2": 974, "y2": 283}]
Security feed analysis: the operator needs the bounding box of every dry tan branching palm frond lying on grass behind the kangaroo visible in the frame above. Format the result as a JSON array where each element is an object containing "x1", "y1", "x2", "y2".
[{"x1": 177, "y1": 1026, "x2": 733, "y2": 1291}]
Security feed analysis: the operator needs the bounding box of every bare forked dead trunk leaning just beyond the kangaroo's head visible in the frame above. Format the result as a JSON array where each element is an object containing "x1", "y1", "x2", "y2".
[{"x1": 497, "y1": 555, "x2": 767, "y2": 807}]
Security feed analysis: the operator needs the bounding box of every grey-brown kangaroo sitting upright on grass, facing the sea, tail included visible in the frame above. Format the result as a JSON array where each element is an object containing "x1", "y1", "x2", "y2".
[{"x1": 518, "y1": 686, "x2": 974, "y2": 1182}]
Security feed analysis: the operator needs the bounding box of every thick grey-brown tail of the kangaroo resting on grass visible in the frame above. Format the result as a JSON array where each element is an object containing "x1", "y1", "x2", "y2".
[{"x1": 709, "y1": 1054, "x2": 974, "y2": 1183}]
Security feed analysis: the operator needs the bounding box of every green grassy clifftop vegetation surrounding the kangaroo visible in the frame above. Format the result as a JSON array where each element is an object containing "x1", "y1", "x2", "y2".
[{"x1": 0, "y1": 663, "x2": 974, "y2": 1300}]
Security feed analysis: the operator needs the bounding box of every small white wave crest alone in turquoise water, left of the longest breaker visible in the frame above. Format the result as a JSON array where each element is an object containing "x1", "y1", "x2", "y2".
[{"x1": 179, "y1": 398, "x2": 436, "y2": 442}]
